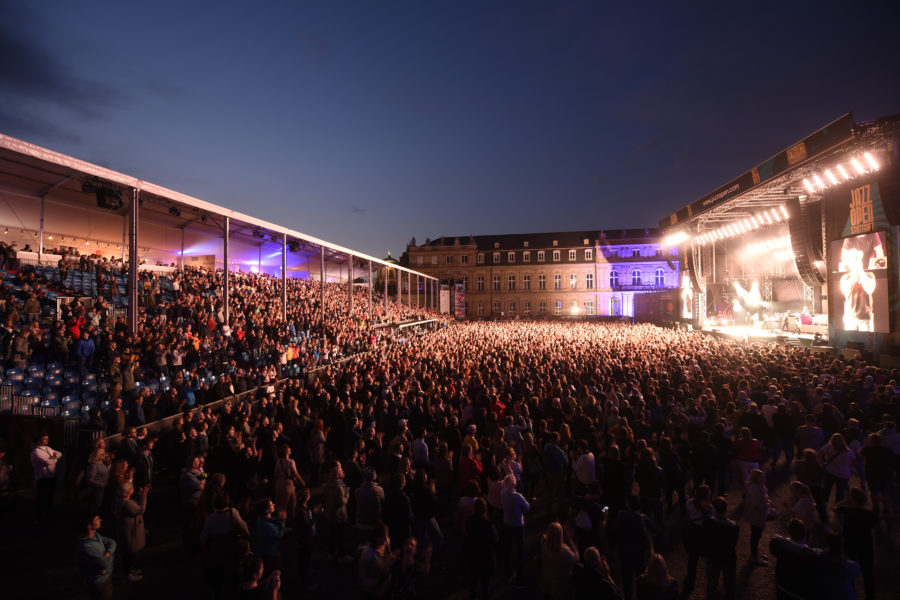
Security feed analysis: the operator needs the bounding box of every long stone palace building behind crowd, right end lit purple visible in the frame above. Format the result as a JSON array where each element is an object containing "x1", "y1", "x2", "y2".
[{"x1": 400, "y1": 229, "x2": 680, "y2": 319}]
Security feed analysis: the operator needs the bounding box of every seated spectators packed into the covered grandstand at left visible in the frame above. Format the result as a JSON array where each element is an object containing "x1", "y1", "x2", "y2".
[{"x1": 0, "y1": 256, "x2": 436, "y2": 433}]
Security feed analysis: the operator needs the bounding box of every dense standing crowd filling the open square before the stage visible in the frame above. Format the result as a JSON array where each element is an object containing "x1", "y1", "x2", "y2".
[{"x1": 12, "y1": 318, "x2": 900, "y2": 600}]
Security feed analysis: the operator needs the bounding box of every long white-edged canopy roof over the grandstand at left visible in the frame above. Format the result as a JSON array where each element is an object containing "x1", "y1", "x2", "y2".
[{"x1": 0, "y1": 134, "x2": 434, "y2": 279}]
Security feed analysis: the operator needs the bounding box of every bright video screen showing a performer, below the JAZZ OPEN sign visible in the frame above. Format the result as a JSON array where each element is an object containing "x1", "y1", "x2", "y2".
[{"x1": 830, "y1": 232, "x2": 891, "y2": 333}]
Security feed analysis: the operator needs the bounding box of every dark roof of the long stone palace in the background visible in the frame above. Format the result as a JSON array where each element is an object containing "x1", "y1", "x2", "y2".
[{"x1": 414, "y1": 227, "x2": 659, "y2": 250}]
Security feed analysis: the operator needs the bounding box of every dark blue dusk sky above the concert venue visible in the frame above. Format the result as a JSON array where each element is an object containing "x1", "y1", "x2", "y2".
[{"x1": 0, "y1": 0, "x2": 900, "y2": 256}]
